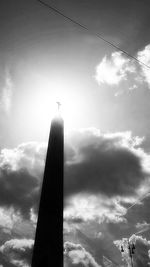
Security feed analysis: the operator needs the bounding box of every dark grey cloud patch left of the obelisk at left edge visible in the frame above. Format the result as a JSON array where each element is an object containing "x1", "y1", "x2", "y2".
[{"x1": 0, "y1": 169, "x2": 39, "y2": 220}]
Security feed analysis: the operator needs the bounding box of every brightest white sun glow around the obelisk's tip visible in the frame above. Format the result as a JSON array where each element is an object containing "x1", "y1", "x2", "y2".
[{"x1": 27, "y1": 75, "x2": 82, "y2": 134}]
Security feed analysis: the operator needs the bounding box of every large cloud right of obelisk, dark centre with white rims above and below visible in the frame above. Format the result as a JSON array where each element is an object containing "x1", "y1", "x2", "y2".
[{"x1": 64, "y1": 128, "x2": 150, "y2": 223}]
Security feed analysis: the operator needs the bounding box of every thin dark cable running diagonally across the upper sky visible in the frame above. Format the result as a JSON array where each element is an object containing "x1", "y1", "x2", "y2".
[{"x1": 37, "y1": 0, "x2": 150, "y2": 69}]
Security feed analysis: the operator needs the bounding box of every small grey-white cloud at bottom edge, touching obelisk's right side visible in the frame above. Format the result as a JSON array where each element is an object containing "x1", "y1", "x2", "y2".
[{"x1": 64, "y1": 241, "x2": 101, "y2": 267}]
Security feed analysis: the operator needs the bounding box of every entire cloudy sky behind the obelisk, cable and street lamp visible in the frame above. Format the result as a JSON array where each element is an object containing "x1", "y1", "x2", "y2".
[{"x1": 0, "y1": 0, "x2": 150, "y2": 267}]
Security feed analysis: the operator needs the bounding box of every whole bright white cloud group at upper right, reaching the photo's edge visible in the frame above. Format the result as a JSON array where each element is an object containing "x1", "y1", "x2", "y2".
[{"x1": 95, "y1": 44, "x2": 150, "y2": 93}]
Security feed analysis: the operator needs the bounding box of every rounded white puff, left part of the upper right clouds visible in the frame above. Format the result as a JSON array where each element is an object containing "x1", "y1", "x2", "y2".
[{"x1": 95, "y1": 52, "x2": 135, "y2": 85}]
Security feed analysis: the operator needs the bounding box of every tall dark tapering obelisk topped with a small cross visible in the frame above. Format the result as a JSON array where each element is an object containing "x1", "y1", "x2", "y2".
[{"x1": 31, "y1": 107, "x2": 64, "y2": 267}]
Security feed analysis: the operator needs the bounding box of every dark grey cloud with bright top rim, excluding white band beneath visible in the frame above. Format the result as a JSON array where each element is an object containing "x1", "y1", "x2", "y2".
[{"x1": 65, "y1": 131, "x2": 147, "y2": 201}]
